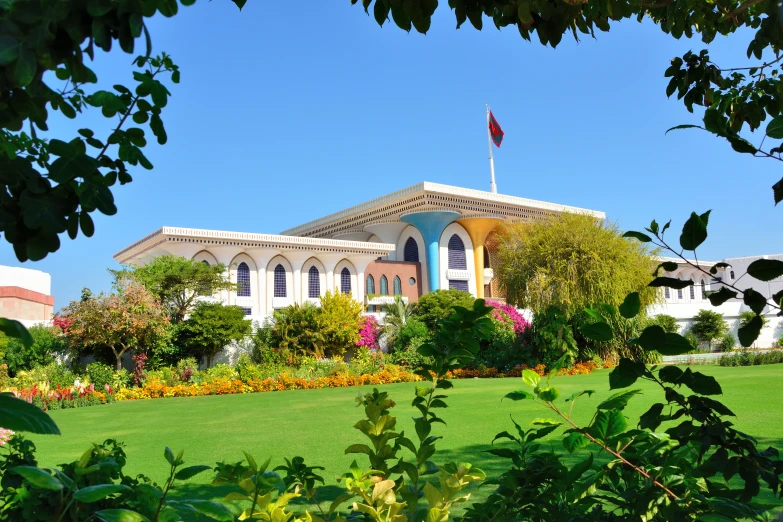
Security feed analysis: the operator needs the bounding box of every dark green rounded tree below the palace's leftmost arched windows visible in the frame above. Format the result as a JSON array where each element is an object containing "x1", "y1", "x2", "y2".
[{"x1": 177, "y1": 302, "x2": 252, "y2": 368}]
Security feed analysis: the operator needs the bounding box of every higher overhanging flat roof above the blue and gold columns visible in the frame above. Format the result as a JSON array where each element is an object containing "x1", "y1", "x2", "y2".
[{"x1": 281, "y1": 181, "x2": 606, "y2": 237}]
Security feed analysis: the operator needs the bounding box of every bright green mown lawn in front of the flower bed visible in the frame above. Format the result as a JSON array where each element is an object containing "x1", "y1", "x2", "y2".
[{"x1": 27, "y1": 365, "x2": 783, "y2": 510}]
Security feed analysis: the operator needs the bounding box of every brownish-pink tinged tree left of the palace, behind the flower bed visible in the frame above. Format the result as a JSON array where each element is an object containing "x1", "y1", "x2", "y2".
[{"x1": 59, "y1": 280, "x2": 169, "y2": 370}]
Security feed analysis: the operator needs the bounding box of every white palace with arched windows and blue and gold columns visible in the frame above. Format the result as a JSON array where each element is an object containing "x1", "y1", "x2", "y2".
[{"x1": 114, "y1": 182, "x2": 605, "y2": 320}]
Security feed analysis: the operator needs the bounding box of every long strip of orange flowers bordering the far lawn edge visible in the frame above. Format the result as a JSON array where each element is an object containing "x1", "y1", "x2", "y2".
[{"x1": 6, "y1": 362, "x2": 600, "y2": 404}]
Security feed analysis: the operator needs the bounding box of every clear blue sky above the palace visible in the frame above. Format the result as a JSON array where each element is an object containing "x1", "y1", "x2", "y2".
[{"x1": 0, "y1": 0, "x2": 783, "y2": 308}]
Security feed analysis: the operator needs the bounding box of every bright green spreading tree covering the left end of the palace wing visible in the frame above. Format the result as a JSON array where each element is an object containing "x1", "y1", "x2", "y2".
[{"x1": 109, "y1": 254, "x2": 235, "y2": 324}]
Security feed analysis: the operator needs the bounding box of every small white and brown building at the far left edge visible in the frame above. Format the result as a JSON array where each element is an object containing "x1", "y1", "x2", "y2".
[{"x1": 0, "y1": 266, "x2": 54, "y2": 327}]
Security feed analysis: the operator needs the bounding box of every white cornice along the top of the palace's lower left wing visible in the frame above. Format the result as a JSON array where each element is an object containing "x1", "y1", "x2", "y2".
[{"x1": 114, "y1": 227, "x2": 396, "y2": 263}]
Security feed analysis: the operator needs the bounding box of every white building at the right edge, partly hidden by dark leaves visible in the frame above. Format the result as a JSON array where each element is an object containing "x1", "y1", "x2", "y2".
[{"x1": 649, "y1": 254, "x2": 783, "y2": 348}]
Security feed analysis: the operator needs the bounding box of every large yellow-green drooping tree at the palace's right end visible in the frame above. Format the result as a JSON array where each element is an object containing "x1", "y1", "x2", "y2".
[{"x1": 497, "y1": 213, "x2": 659, "y2": 319}]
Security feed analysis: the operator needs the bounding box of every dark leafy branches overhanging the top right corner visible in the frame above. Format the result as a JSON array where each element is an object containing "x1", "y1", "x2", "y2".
[{"x1": 351, "y1": 0, "x2": 783, "y2": 204}]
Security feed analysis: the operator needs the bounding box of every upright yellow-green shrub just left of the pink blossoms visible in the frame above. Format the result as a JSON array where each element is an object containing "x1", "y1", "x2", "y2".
[{"x1": 317, "y1": 291, "x2": 362, "y2": 358}]
